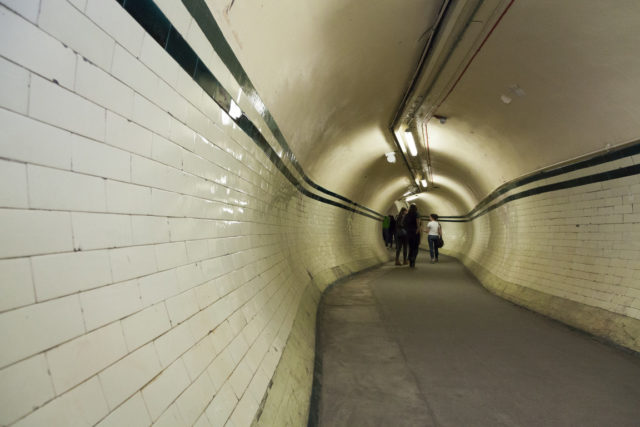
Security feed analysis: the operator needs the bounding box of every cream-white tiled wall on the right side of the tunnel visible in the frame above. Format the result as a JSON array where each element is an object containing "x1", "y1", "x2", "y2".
[{"x1": 445, "y1": 162, "x2": 640, "y2": 351}]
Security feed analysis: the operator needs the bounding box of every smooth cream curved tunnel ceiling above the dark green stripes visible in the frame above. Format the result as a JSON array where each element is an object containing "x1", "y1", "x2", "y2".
[{"x1": 207, "y1": 0, "x2": 640, "y2": 215}]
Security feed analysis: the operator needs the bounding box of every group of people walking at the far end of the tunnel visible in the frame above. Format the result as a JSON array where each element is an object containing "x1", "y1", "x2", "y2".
[{"x1": 382, "y1": 204, "x2": 442, "y2": 268}]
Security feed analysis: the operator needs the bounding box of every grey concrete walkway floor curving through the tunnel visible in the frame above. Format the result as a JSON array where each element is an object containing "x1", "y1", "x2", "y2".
[{"x1": 309, "y1": 252, "x2": 640, "y2": 427}]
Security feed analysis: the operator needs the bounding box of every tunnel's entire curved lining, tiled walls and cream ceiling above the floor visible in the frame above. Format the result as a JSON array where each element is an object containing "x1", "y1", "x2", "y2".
[{"x1": 0, "y1": 0, "x2": 640, "y2": 427}]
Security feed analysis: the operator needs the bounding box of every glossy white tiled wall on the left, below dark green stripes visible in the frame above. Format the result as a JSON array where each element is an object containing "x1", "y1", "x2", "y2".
[{"x1": 0, "y1": 0, "x2": 387, "y2": 426}]
